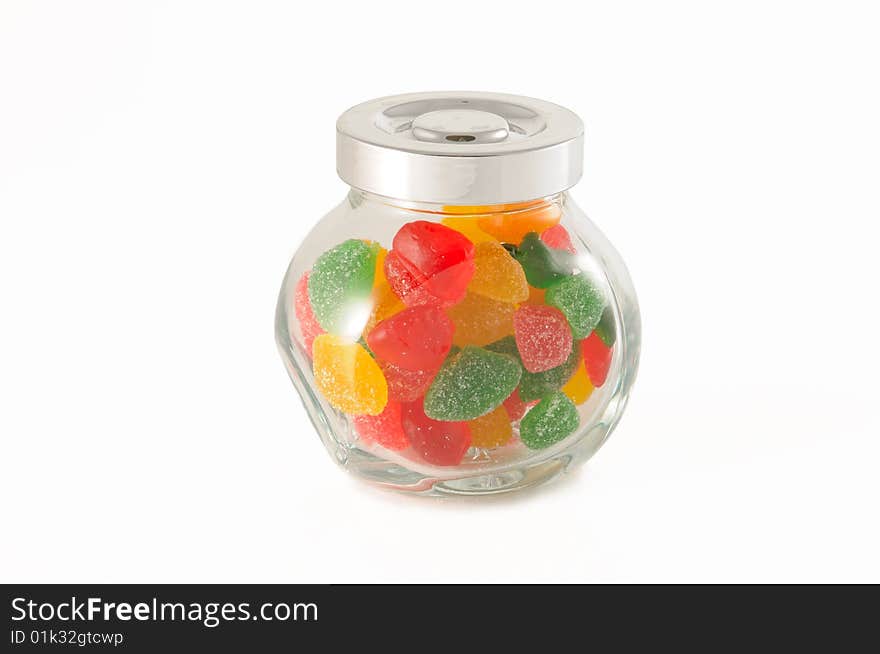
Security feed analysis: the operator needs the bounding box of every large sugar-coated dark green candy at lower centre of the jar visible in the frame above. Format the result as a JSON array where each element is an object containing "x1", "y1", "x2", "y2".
[{"x1": 425, "y1": 345, "x2": 522, "y2": 420}]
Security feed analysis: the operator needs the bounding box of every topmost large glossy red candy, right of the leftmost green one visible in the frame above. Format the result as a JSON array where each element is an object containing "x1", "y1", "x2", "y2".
[{"x1": 385, "y1": 220, "x2": 474, "y2": 307}]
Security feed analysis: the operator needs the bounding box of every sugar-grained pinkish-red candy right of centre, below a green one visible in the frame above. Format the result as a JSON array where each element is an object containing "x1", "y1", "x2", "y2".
[{"x1": 513, "y1": 304, "x2": 573, "y2": 372}]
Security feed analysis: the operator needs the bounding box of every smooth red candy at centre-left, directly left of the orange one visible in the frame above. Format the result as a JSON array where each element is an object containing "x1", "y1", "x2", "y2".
[{"x1": 367, "y1": 306, "x2": 454, "y2": 370}]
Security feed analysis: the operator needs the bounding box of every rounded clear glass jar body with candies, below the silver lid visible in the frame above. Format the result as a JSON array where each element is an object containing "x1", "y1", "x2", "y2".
[{"x1": 275, "y1": 190, "x2": 640, "y2": 495}]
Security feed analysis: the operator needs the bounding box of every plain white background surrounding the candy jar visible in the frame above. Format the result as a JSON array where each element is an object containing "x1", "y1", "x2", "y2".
[{"x1": 0, "y1": 0, "x2": 880, "y2": 582}]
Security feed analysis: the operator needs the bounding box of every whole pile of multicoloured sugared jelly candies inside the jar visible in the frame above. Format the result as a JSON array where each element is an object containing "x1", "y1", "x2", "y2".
[{"x1": 295, "y1": 201, "x2": 615, "y2": 466}]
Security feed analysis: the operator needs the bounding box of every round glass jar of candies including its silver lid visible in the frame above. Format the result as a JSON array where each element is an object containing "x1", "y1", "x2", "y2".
[{"x1": 276, "y1": 93, "x2": 640, "y2": 495}]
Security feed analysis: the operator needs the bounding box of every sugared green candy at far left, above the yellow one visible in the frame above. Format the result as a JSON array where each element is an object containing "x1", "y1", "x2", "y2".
[{"x1": 309, "y1": 239, "x2": 379, "y2": 338}]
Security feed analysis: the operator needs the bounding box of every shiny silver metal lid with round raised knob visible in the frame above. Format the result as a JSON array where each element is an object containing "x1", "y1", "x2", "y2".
[{"x1": 336, "y1": 91, "x2": 584, "y2": 205}]
